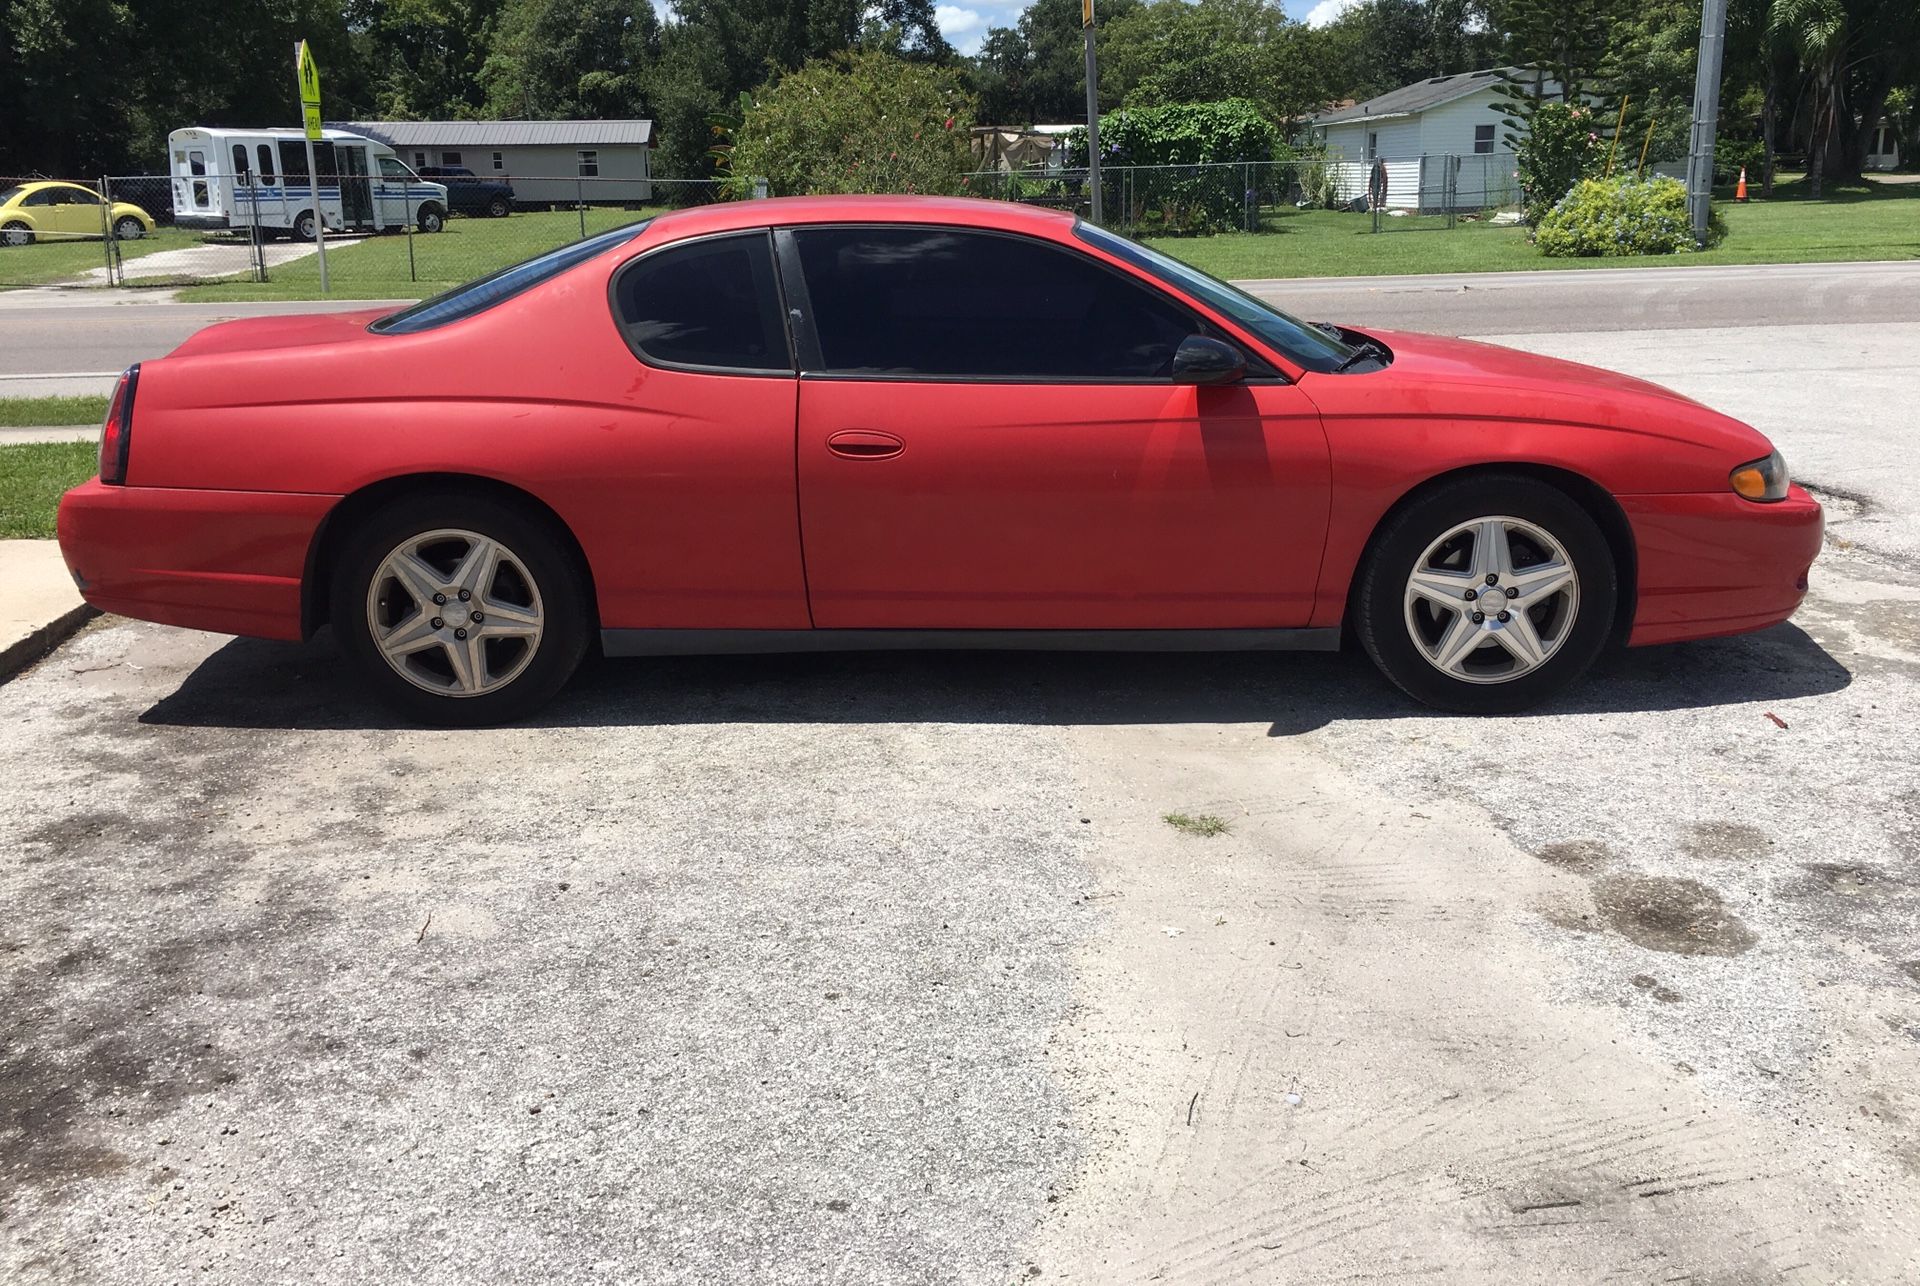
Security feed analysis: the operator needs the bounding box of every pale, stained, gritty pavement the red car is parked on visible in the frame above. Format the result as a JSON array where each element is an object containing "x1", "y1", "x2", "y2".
[{"x1": 0, "y1": 266, "x2": 1920, "y2": 1282}]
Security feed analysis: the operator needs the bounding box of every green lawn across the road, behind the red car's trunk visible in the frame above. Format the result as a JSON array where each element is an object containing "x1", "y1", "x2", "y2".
[{"x1": 179, "y1": 209, "x2": 660, "y2": 301}]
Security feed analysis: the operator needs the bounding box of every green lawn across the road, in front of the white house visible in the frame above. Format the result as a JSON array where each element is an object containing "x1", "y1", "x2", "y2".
[{"x1": 1154, "y1": 180, "x2": 1920, "y2": 280}]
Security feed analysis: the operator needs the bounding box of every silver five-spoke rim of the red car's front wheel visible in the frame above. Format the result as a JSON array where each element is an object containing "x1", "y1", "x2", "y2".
[{"x1": 1405, "y1": 514, "x2": 1580, "y2": 683}]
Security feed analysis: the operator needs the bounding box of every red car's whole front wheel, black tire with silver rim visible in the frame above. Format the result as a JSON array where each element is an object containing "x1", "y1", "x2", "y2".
[{"x1": 1356, "y1": 474, "x2": 1619, "y2": 714}]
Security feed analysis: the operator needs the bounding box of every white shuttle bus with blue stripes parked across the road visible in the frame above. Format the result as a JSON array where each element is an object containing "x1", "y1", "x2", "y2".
[{"x1": 167, "y1": 129, "x2": 447, "y2": 242}]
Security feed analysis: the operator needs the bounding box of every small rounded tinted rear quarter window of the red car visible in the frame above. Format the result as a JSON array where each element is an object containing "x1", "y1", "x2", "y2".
[{"x1": 614, "y1": 232, "x2": 793, "y2": 372}]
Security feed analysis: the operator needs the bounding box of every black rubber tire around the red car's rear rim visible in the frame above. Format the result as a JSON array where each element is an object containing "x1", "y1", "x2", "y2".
[{"x1": 328, "y1": 489, "x2": 591, "y2": 727}]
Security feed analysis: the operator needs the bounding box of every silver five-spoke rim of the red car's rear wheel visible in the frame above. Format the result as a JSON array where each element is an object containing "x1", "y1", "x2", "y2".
[{"x1": 367, "y1": 528, "x2": 547, "y2": 697}]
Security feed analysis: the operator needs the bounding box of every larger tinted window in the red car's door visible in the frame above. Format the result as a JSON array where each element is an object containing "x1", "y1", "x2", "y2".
[{"x1": 795, "y1": 226, "x2": 1200, "y2": 380}]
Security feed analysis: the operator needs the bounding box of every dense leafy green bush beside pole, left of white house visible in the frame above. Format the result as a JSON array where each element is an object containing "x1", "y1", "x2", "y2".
[{"x1": 1066, "y1": 98, "x2": 1283, "y2": 232}]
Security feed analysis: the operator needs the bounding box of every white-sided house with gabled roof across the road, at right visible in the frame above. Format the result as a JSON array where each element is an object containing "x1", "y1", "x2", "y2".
[{"x1": 1313, "y1": 67, "x2": 1559, "y2": 211}]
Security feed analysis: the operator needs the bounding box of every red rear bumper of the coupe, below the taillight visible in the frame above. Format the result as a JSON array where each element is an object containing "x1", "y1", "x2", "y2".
[{"x1": 60, "y1": 478, "x2": 340, "y2": 639}]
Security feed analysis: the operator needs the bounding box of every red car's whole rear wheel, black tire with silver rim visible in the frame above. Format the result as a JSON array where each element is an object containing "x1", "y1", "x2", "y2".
[{"x1": 332, "y1": 491, "x2": 589, "y2": 727}]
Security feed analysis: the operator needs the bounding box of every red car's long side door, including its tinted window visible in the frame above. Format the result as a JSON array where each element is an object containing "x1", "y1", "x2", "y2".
[{"x1": 780, "y1": 225, "x2": 1329, "y2": 630}]
